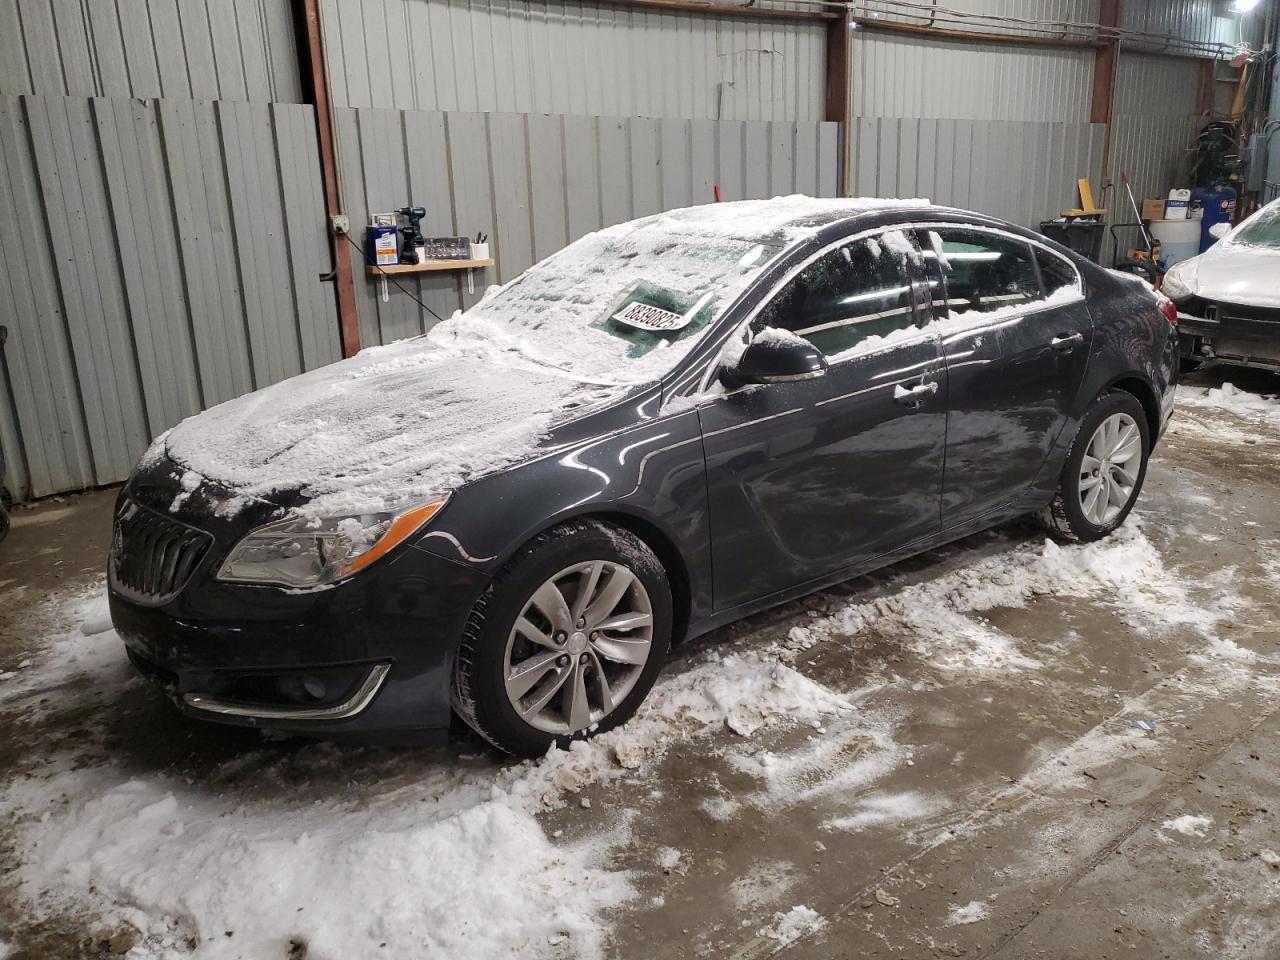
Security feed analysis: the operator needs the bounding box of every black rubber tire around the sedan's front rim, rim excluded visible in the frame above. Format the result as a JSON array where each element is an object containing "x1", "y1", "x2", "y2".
[{"x1": 453, "y1": 520, "x2": 672, "y2": 756}]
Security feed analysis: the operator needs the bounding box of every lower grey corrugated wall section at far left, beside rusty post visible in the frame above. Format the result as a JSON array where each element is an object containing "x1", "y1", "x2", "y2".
[{"x1": 0, "y1": 96, "x2": 339, "y2": 497}]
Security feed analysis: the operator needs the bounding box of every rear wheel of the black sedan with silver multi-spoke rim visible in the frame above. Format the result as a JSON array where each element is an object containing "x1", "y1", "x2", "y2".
[{"x1": 1041, "y1": 390, "x2": 1151, "y2": 541}]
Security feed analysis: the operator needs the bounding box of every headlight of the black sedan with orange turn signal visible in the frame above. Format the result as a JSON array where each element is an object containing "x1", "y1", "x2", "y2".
[{"x1": 218, "y1": 497, "x2": 448, "y2": 588}]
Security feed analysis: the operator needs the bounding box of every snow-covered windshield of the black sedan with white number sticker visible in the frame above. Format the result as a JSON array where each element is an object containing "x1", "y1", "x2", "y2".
[{"x1": 451, "y1": 216, "x2": 780, "y2": 384}]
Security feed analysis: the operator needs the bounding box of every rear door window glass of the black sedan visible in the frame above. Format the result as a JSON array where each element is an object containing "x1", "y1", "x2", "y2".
[{"x1": 929, "y1": 227, "x2": 1042, "y2": 314}]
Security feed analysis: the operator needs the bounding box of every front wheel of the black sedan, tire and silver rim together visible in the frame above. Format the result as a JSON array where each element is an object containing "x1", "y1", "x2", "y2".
[{"x1": 453, "y1": 521, "x2": 672, "y2": 756}]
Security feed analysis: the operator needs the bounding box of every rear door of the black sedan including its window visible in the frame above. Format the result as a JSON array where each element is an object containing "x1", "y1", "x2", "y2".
[{"x1": 919, "y1": 224, "x2": 1093, "y2": 529}]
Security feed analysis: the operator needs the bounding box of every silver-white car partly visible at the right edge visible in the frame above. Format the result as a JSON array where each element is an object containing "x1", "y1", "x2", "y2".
[{"x1": 1161, "y1": 200, "x2": 1280, "y2": 371}]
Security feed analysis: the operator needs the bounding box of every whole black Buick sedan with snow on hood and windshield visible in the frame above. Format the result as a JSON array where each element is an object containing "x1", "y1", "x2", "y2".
[{"x1": 109, "y1": 197, "x2": 1178, "y2": 755}]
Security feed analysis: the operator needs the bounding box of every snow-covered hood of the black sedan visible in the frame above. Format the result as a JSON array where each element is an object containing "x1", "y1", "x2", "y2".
[{"x1": 162, "y1": 337, "x2": 626, "y2": 516}]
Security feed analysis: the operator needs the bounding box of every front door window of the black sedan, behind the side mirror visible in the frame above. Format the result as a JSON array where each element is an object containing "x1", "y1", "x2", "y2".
[{"x1": 751, "y1": 230, "x2": 915, "y2": 358}]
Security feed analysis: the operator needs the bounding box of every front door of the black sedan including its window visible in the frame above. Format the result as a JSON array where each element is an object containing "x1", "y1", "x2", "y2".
[{"x1": 699, "y1": 232, "x2": 946, "y2": 609}]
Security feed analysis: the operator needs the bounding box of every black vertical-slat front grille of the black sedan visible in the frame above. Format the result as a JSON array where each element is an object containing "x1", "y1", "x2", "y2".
[{"x1": 111, "y1": 500, "x2": 212, "y2": 604}]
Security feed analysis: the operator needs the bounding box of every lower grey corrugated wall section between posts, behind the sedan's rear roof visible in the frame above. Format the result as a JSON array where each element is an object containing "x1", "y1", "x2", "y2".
[{"x1": 852, "y1": 119, "x2": 1105, "y2": 227}]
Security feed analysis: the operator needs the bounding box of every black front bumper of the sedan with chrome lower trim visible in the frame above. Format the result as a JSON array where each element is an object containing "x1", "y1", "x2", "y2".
[{"x1": 109, "y1": 537, "x2": 489, "y2": 739}]
